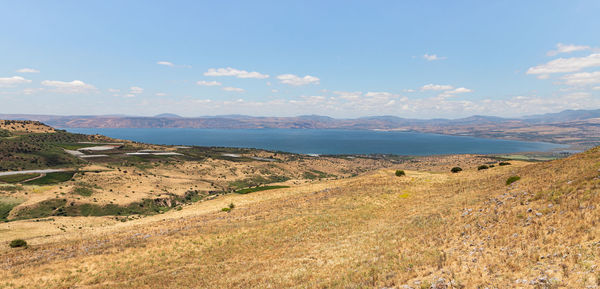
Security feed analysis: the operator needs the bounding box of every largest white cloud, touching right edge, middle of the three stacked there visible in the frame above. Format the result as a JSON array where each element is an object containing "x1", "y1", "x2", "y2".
[{"x1": 527, "y1": 53, "x2": 600, "y2": 74}]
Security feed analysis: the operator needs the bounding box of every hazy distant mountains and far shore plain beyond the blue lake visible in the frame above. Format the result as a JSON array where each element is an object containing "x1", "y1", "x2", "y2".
[{"x1": 0, "y1": 109, "x2": 600, "y2": 147}]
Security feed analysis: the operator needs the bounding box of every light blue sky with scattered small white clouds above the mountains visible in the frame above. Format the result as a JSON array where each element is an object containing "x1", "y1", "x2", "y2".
[{"x1": 0, "y1": 1, "x2": 600, "y2": 118}]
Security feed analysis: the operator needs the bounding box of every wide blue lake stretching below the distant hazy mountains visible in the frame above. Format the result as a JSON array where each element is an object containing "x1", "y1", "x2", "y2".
[{"x1": 66, "y1": 128, "x2": 566, "y2": 155}]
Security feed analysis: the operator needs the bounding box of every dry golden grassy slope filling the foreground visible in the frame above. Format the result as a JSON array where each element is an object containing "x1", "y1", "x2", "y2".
[{"x1": 0, "y1": 149, "x2": 600, "y2": 288}]
